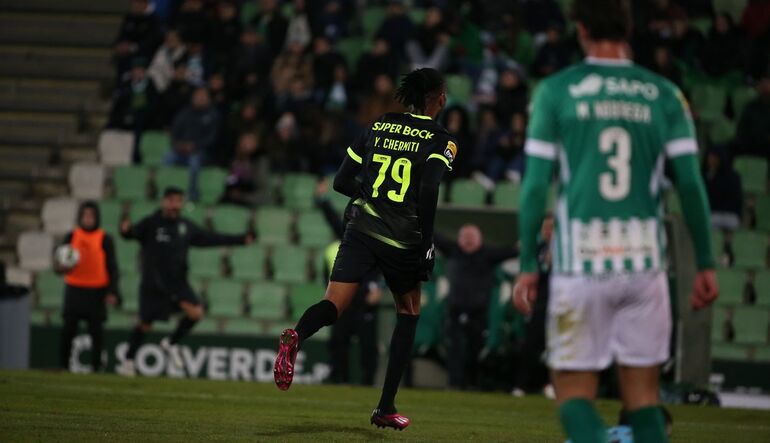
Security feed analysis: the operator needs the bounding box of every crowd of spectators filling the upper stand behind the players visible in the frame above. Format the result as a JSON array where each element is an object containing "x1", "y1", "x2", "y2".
[{"x1": 109, "y1": 0, "x2": 770, "y2": 226}]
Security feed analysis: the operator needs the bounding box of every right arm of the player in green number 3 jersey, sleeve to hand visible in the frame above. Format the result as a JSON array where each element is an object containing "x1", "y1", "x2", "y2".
[{"x1": 664, "y1": 87, "x2": 719, "y2": 309}]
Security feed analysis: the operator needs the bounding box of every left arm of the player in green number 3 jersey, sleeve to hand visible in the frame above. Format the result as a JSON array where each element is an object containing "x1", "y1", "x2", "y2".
[{"x1": 513, "y1": 82, "x2": 559, "y2": 314}]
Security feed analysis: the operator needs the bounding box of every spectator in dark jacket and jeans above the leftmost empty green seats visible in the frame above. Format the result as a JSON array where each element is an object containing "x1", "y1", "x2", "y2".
[{"x1": 164, "y1": 88, "x2": 221, "y2": 201}]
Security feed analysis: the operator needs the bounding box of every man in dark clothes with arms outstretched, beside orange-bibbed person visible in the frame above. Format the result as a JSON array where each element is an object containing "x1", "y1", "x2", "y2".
[{"x1": 118, "y1": 188, "x2": 253, "y2": 376}]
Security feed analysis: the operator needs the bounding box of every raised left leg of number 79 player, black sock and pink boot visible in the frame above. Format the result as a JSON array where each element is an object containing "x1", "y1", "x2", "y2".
[{"x1": 273, "y1": 282, "x2": 358, "y2": 391}]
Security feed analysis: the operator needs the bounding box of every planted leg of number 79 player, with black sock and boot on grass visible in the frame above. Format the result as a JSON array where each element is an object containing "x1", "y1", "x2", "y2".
[{"x1": 371, "y1": 284, "x2": 422, "y2": 431}]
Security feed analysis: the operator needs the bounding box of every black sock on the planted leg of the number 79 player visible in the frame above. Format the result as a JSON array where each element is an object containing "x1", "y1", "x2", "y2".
[{"x1": 377, "y1": 314, "x2": 420, "y2": 414}]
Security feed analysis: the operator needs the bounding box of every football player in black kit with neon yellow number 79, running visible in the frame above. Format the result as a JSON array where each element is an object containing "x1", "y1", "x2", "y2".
[{"x1": 274, "y1": 68, "x2": 457, "y2": 430}]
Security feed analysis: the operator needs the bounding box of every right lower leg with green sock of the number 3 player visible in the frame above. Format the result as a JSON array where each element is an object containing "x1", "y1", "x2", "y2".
[{"x1": 618, "y1": 366, "x2": 668, "y2": 443}]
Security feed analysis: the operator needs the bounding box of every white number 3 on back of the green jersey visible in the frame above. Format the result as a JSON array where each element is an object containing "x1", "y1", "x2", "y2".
[{"x1": 599, "y1": 126, "x2": 631, "y2": 201}]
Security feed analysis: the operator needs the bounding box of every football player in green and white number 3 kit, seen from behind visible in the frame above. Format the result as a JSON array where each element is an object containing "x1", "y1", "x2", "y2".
[{"x1": 514, "y1": 0, "x2": 718, "y2": 443}]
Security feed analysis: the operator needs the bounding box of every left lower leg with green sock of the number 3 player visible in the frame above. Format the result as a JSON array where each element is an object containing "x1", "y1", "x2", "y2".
[{"x1": 551, "y1": 370, "x2": 607, "y2": 443}]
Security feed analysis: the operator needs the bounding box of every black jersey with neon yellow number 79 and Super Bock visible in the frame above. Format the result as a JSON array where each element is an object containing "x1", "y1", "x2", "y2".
[{"x1": 348, "y1": 113, "x2": 457, "y2": 249}]
